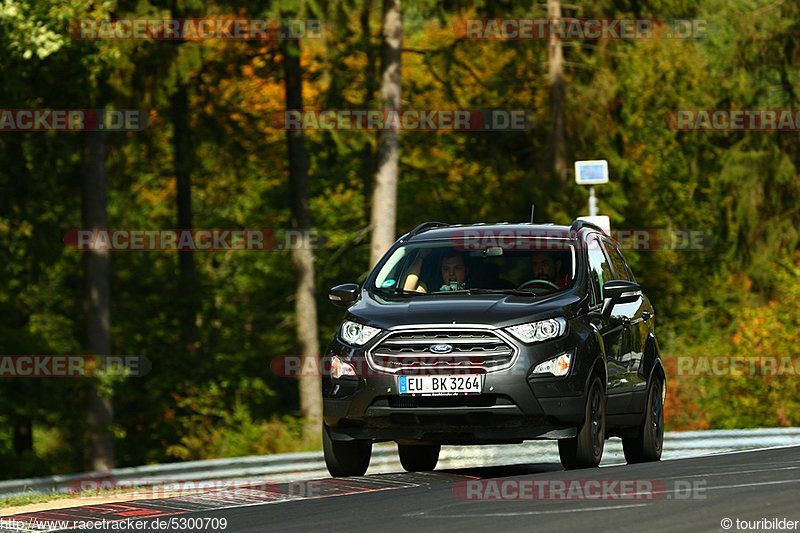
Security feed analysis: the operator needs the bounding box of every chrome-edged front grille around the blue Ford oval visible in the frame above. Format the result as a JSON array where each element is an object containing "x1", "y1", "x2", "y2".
[{"x1": 368, "y1": 329, "x2": 516, "y2": 375}]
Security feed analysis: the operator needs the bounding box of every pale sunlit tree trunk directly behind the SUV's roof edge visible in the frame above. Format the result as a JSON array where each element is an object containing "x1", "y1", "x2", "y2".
[{"x1": 370, "y1": 0, "x2": 403, "y2": 266}]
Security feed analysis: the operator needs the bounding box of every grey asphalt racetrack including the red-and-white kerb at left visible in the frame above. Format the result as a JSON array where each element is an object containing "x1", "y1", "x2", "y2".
[{"x1": 6, "y1": 446, "x2": 800, "y2": 533}]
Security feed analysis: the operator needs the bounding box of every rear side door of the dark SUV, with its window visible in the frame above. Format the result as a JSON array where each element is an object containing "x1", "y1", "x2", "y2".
[{"x1": 603, "y1": 239, "x2": 649, "y2": 410}]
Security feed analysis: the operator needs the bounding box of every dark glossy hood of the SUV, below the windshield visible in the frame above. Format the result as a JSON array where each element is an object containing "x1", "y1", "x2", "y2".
[{"x1": 348, "y1": 291, "x2": 580, "y2": 329}]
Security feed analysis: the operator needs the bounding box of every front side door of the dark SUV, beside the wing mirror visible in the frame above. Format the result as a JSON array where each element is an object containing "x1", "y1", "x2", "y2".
[{"x1": 586, "y1": 233, "x2": 631, "y2": 414}]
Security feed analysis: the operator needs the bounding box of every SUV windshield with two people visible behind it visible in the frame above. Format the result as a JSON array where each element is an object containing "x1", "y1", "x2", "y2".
[{"x1": 375, "y1": 239, "x2": 575, "y2": 295}]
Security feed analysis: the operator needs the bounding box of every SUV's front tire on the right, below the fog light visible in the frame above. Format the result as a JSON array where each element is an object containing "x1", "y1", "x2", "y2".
[{"x1": 558, "y1": 376, "x2": 606, "y2": 470}]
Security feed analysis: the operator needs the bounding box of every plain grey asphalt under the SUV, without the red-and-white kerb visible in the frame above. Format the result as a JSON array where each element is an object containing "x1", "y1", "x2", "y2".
[{"x1": 180, "y1": 447, "x2": 800, "y2": 533}]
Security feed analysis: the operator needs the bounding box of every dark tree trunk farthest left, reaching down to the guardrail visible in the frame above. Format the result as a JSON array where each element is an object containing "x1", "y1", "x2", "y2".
[{"x1": 83, "y1": 131, "x2": 114, "y2": 471}]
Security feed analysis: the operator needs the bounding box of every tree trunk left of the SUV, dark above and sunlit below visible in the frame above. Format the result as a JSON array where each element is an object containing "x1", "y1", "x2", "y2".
[{"x1": 283, "y1": 39, "x2": 322, "y2": 438}]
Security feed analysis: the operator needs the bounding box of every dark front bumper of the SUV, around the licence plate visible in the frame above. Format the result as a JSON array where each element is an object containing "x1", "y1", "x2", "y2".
[{"x1": 323, "y1": 328, "x2": 594, "y2": 444}]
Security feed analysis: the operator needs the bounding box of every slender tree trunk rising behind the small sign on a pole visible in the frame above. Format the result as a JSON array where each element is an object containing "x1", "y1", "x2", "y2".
[{"x1": 547, "y1": 0, "x2": 567, "y2": 185}]
